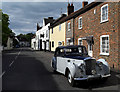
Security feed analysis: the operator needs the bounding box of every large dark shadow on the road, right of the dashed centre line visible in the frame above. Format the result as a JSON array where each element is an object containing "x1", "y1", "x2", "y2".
[{"x1": 2, "y1": 49, "x2": 58, "y2": 91}]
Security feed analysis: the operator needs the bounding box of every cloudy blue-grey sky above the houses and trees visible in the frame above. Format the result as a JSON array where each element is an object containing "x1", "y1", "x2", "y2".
[{"x1": 2, "y1": 0, "x2": 94, "y2": 35}]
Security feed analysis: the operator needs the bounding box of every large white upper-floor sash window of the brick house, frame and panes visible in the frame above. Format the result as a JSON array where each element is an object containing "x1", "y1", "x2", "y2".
[{"x1": 101, "y1": 4, "x2": 108, "y2": 22}]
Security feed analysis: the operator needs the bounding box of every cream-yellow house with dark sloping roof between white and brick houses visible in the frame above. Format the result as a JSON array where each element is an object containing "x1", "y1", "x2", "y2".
[{"x1": 50, "y1": 14, "x2": 66, "y2": 52}]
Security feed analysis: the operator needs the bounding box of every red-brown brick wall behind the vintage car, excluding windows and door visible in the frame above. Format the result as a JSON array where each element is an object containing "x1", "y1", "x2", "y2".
[{"x1": 75, "y1": 2, "x2": 119, "y2": 69}]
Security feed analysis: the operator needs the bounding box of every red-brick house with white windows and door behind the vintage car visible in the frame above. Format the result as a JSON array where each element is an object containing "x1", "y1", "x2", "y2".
[{"x1": 74, "y1": 2, "x2": 120, "y2": 69}]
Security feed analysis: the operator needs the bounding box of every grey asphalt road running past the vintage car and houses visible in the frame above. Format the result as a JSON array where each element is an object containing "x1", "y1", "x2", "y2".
[{"x1": 0, "y1": 48, "x2": 120, "y2": 92}]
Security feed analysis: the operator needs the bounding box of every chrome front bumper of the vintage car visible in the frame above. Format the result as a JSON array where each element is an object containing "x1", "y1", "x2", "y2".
[{"x1": 74, "y1": 74, "x2": 111, "y2": 80}]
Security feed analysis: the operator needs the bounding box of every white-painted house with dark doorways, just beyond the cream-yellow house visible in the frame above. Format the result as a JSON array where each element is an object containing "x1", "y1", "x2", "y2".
[{"x1": 31, "y1": 17, "x2": 54, "y2": 51}]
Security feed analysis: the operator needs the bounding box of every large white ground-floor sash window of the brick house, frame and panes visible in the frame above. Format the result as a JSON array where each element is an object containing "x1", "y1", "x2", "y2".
[{"x1": 100, "y1": 35, "x2": 109, "y2": 55}]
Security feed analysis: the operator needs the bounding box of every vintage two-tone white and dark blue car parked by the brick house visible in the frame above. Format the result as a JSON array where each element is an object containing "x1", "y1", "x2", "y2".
[{"x1": 51, "y1": 46, "x2": 110, "y2": 86}]
